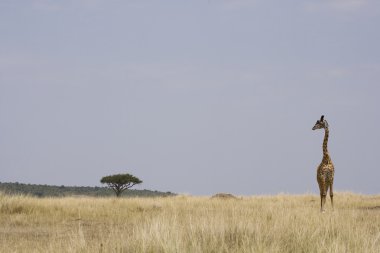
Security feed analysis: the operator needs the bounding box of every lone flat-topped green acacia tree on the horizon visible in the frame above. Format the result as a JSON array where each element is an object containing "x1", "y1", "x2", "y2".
[{"x1": 100, "y1": 174, "x2": 142, "y2": 197}]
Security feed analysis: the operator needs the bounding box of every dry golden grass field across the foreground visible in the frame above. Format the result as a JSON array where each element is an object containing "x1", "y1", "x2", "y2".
[{"x1": 0, "y1": 193, "x2": 380, "y2": 252}]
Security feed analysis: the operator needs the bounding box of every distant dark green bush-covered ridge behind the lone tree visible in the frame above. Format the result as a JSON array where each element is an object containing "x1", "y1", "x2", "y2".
[{"x1": 0, "y1": 182, "x2": 176, "y2": 198}]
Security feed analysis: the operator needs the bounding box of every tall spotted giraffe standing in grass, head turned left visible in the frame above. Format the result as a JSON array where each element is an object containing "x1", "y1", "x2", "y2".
[{"x1": 313, "y1": 115, "x2": 334, "y2": 212}]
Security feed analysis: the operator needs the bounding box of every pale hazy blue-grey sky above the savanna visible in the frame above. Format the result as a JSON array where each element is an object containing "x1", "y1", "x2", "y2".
[{"x1": 0, "y1": 0, "x2": 380, "y2": 195}]
